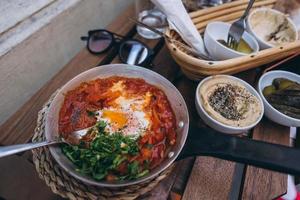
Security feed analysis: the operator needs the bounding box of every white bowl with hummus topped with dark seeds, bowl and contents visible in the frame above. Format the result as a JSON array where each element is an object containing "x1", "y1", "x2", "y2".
[{"x1": 195, "y1": 75, "x2": 264, "y2": 134}]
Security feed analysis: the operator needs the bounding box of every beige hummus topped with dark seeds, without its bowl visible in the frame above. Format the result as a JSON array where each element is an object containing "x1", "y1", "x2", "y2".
[{"x1": 199, "y1": 76, "x2": 262, "y2": 127}]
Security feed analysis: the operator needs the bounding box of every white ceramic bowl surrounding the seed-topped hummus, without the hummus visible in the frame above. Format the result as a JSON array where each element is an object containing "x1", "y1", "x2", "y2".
[{"x1": 195, "y1": 75, "x2": 264, "y2": 134}]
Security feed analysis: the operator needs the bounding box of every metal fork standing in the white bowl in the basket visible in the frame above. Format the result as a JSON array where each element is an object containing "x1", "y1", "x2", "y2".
[{"x1": 227, "y1": 0, "x2": 255, "y2": 49}]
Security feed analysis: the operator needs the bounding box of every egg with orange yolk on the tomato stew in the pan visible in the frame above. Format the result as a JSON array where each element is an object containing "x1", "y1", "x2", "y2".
[{"x1": 96, "y1": 81, "x2": 151, "y2": 138}]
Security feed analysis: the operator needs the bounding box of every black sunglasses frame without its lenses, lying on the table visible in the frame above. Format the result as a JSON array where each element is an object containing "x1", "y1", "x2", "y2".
[{"x1": 81, "y1": 29, "x2": 154, "y2": 66}]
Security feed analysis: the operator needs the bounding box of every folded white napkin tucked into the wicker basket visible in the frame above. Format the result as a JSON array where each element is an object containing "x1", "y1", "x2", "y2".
[{"x1": 151, "y1": 0, "x2": 207, "y2": 55}]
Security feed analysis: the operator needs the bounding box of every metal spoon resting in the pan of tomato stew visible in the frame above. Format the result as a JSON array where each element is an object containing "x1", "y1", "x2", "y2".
[{"x1": 0, "y1": 127, "x2": 91, "y2": 158}]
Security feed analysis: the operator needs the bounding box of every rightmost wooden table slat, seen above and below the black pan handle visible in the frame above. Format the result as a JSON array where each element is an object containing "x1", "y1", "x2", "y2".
[{"x1": 242, "y1": 119, "x2": 290, "y2": 199}]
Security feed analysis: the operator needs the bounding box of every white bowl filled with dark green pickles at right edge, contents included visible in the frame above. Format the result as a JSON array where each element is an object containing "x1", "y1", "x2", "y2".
[{"x1": 258, "y1": 70, "x2": 300, "y2": 127}]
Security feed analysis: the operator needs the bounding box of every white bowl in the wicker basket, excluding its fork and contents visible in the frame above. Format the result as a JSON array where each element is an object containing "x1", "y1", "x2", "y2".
[{"x1": 204, "y1": 22, "x2": 259, "y2": 60}]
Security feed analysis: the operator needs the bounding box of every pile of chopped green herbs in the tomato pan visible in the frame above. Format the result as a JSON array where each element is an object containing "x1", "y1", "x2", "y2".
[{"x1": 62, "y1": 121, "x2": 149, "y2": 180}]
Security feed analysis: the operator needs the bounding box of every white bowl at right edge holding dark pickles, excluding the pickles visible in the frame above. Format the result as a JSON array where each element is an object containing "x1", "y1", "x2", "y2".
[{"x1": 257, "y1": 70, "x2": 300, "y2": 127}]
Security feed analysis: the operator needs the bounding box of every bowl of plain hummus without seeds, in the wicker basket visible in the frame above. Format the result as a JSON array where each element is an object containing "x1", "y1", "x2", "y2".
[{"x1": 247, "y1": 8, "x2": 298, "y2": 49}]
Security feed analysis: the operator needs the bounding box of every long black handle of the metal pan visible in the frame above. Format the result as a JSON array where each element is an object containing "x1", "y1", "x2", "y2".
[{"x1": 177, "y1": 127, "x2": 300, "y2": 175}]
